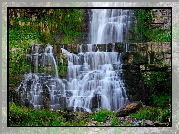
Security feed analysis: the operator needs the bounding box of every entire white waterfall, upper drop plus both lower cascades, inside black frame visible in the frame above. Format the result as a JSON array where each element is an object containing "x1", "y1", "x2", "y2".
[{"x1": 17, "y1": 5, "x2": 136, "y2": 112}]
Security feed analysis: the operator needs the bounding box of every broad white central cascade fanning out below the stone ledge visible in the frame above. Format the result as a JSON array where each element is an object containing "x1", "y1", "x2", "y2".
[{"x1": 62, "y1": 44, "x2": 128, "y2": 111}]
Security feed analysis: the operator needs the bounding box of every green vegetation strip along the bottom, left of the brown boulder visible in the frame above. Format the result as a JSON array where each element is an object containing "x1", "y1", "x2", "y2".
[{"x1": 9, "y1": 102, "x2": 117, "y2": 126}]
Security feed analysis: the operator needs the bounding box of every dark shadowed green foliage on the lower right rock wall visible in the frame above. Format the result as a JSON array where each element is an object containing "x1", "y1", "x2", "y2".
[{"x1": 142, "y1": 71, "x2": 171, "y2": 107}]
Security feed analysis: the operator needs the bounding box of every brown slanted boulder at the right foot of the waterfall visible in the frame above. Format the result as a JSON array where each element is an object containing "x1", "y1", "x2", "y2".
[{"x1": 116, "y1": 101, "x2": 143, "y2": 117}]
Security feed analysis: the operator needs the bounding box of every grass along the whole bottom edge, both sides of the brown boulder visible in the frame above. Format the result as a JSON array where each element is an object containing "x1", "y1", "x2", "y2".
[{"x1": 9, "y1": 102, "x2": 170, "y2": 126}]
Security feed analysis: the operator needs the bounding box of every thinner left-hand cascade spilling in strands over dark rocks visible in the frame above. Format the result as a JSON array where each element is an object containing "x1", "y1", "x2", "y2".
[{"x1": 16, "y1": 44, "x2": 65, "y2": 109}]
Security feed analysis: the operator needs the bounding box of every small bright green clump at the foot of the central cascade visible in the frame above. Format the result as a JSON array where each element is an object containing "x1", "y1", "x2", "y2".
[{"x1": 91, "y1": 109, "x2": 114, "y2": 122}]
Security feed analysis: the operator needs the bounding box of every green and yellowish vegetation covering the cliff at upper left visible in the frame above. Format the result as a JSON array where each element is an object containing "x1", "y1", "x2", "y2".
[{"x1": 8, "y1": 8, "x2": 83, "y2": 87}]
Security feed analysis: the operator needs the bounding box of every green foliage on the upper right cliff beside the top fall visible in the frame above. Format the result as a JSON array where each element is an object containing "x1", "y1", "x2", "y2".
[{"x1": 129, "y1": 9, "x2": 171, "y2": 42}]
